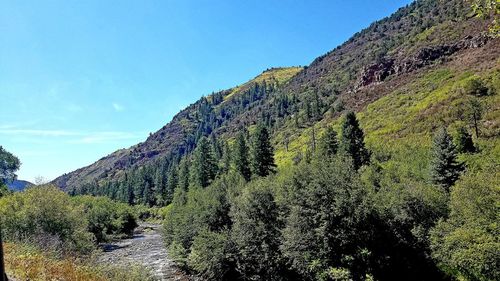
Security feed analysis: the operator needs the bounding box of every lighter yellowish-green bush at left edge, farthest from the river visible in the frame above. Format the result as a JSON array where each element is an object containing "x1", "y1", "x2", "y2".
[{"x1": 0, "y1": 186, "x2": 94, "y2": 254}]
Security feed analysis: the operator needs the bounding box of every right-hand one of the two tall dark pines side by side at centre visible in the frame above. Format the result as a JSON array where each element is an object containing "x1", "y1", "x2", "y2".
[{"x1": 252, "y1": 124, "x2": 276, "y2": 177}]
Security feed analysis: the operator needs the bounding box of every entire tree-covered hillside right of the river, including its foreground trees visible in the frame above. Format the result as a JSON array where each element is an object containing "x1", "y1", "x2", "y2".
[{"x1": 54, "y1": 0, "x2": 500, "y2": 280}]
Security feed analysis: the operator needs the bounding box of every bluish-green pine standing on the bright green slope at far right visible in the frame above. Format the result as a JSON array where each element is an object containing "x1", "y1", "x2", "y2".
[{"x1": 431, "y1": 128, "x2": 463, "y2": 189}]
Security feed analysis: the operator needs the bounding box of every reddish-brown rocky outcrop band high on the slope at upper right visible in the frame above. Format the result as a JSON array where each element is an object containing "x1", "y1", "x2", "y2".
[{"x1": 355, "y1": 35, "x2": 489, "y2": 89}]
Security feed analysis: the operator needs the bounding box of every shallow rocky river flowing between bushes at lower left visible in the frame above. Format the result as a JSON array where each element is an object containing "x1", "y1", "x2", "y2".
[{"x1": 99, "y1": 223, "x2": 190, "y2": 281}]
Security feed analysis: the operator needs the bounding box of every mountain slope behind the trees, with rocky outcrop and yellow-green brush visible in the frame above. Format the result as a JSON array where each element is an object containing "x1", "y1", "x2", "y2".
[{"x1": 54, "y1": 0, "x2": 500, "y2": 194}]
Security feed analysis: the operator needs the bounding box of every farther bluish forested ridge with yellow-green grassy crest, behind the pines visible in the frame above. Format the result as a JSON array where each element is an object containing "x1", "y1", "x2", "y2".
[{"x1": 54, "y1": 67, "x2": 301, "y2": 189}]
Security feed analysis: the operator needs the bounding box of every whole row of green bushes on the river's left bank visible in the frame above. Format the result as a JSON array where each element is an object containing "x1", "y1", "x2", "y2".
[{"x1": 0, "y1": 185, "x2": 137, "y2": 254}]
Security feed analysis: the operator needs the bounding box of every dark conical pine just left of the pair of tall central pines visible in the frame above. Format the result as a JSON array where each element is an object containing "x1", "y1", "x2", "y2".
[{"x1": 192, "y1": 137, "x2": 217, "y2": 187}]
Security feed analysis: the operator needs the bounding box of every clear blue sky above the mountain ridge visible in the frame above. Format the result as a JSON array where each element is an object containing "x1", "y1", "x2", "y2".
[{"x1": 0, "y1": 0, "x2": 411, "y2": 180}]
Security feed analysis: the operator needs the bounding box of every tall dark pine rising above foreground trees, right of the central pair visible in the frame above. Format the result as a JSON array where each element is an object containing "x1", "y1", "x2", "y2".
[{"x1": 340, "y1": 111, "x2": 370, "y2": 169}]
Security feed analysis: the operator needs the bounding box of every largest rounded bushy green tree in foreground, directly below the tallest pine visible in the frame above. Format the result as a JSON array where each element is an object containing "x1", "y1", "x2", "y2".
[{"x1": 282, "y1": 158, "x2": 370, "y2": 280}]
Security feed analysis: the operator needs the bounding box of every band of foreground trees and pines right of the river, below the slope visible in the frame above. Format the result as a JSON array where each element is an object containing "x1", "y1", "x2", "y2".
[{"x1": 161, "y1": 112, "x2": 492, "y2": 280}]
